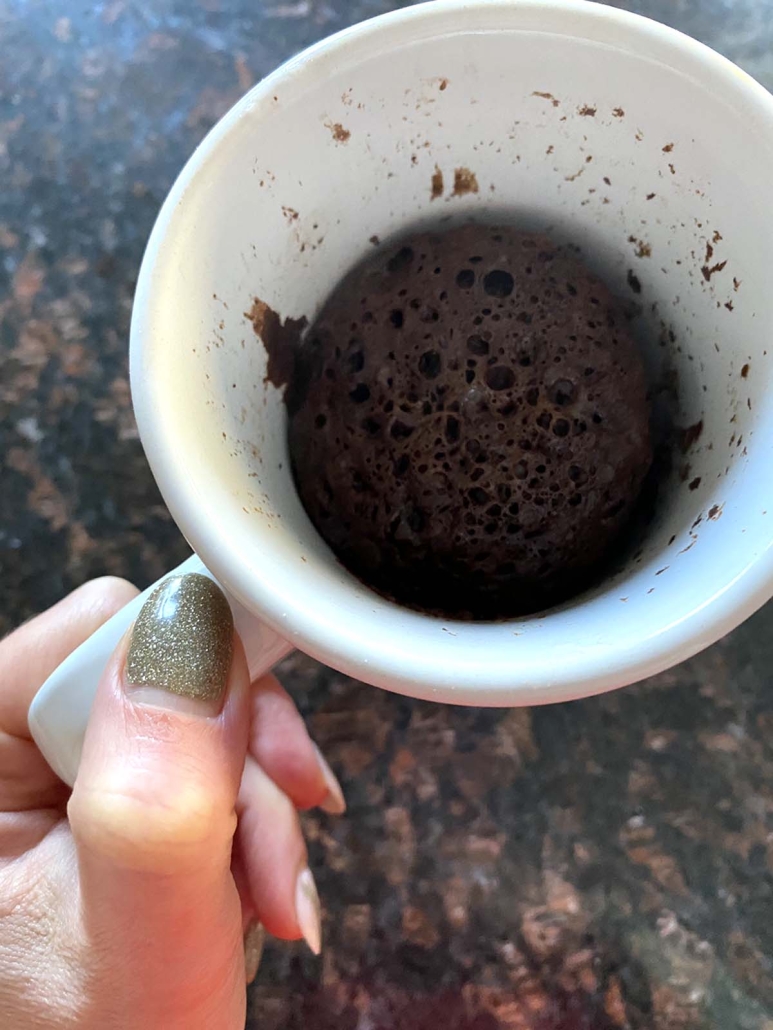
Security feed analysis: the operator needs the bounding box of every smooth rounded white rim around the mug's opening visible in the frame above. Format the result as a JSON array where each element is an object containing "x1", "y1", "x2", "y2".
[{"x1": 131, "y1": 0, "x2": 773, "y2": 706}]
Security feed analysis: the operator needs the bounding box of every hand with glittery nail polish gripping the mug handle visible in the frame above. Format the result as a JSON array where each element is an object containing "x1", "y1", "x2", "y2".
[{"x1": 0, "y1": 575, "x2": 345, "y2": 1030}]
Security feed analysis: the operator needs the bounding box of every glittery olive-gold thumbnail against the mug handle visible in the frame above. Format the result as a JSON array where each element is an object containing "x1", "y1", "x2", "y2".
[{"x1": 126, "y1": 573, "x2": 234, "y2": 711}]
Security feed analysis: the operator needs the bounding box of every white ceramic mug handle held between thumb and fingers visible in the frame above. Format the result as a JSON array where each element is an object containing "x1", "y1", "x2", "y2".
[{"x1": 28, "y1": 554, "x2": 293, "y2": 787}]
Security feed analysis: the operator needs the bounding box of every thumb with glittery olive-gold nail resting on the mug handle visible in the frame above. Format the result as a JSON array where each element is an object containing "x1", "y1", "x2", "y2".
[{"x1": 68, "y1": 574, "x2": 249, "y2": 1030}]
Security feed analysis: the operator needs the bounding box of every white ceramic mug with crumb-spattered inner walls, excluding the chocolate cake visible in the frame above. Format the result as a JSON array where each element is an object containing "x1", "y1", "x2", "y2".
[{"x1": 30, "y1": 0, "x2": 773, "y2": 782}]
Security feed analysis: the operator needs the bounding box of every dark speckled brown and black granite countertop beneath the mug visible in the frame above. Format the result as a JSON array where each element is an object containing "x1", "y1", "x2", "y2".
[{"x1": 0, "y1": 0, "x2": 773, "y2": 1030}]
